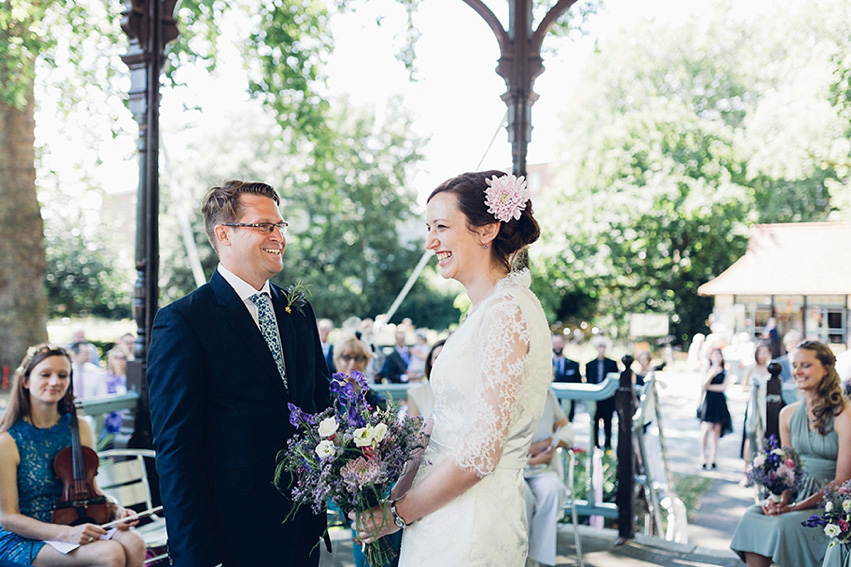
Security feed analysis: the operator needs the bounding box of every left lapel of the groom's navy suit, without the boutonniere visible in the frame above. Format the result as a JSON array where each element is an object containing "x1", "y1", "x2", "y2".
[{"x1": 210, "y1": 271, "x2": 289, "y2": 400}]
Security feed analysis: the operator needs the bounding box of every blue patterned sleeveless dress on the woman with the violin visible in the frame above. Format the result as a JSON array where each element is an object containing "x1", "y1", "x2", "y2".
[{"x1": 0, "y1": 413, "x2": 71, "y2": 565}]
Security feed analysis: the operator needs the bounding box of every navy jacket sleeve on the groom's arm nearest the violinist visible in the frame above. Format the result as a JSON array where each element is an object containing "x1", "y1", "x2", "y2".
[{"x1": 147, "y1": 306, "x2": 218, "y2": 567}]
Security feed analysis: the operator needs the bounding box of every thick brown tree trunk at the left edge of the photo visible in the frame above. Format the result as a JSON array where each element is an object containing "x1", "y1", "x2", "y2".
[{"x1": 0, "y1": 76, "x2": 47, "y2": 382}]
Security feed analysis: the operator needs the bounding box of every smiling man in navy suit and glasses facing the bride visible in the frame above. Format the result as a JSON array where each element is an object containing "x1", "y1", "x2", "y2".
[{"x1": 147, "y1": 181, "x2": 330, "y2": 567}]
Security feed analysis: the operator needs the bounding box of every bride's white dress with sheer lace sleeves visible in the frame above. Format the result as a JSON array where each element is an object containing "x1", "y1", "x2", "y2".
[{"x1": 399, "y1": 270, "x2": 552, "y2": 567}]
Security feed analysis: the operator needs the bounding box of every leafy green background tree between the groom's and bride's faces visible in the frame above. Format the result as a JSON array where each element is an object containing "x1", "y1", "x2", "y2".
[{"x1": 282, "y1": 98, "x2": 421, "y2": 324}]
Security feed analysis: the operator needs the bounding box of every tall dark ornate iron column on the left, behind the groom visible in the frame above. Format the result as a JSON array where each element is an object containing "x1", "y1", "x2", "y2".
[{"x1": 121, "y1": 0, "x2": 177, "y2": 447}]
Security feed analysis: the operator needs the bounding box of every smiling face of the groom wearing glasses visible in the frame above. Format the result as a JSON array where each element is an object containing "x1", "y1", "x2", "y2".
[{"x1": 217, "y1": 194, "x2": 287, "y2": 289}]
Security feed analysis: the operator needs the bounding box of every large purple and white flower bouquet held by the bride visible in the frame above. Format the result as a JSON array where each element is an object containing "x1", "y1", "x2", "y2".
[{"x1": 275, "y1": 371, "x2": 424, "y2": 565}]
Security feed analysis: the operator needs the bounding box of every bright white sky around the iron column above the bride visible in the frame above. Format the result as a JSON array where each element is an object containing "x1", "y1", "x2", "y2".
[{"x1": 328, "y1": 0, "x2": 728, "y2": 200}]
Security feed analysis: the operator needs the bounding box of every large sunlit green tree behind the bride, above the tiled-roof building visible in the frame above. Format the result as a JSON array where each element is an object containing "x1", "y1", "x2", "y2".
[{"x1": 533, "y1": 1, "x2": 849, "y2": 341}]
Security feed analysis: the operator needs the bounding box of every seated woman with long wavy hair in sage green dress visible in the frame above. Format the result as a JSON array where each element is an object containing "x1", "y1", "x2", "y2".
[{"x1": 730, "y1": 340, "x2": 851, "y2": 567}]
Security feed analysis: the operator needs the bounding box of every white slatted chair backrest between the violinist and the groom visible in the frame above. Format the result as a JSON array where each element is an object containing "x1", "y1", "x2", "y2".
[{"x1": 96, "y1": 449, "x2": 155, "y2": 510}]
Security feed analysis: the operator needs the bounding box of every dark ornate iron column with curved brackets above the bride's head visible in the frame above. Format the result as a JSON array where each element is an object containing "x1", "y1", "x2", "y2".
[{"x1": 464, "y1": 0, "x2": 576, "y2": 176}]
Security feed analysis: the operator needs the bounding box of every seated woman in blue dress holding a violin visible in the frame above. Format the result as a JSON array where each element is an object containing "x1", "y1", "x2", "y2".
[{"x1": 0, "y1": 344, "x2": 145, "y2": 567}]
